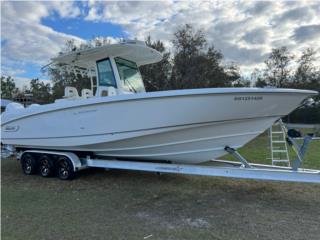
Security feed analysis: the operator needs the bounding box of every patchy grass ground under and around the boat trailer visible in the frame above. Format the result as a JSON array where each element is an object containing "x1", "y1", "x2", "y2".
[{"x1": 1, "y1": 132, "x2": 320, "y2": 240}]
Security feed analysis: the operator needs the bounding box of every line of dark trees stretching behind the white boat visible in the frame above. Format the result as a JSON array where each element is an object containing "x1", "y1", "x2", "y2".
[{"x1": 1, "y1": 24, "x2": 320, "y2": 122}]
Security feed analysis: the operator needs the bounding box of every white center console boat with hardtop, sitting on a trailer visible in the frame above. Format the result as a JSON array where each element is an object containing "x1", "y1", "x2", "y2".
[{"x1": 1, "y1": 41, "x2": 317, "y2": 164}]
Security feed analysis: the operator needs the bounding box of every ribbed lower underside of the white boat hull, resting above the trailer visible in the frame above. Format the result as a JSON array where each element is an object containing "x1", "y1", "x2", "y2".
[{"x1": 77, "y1": 117, "x2": 277, "y2": 163}]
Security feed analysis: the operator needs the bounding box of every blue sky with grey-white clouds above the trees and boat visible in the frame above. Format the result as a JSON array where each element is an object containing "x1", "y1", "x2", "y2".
[{"x1": 1, "y1": 1, "x2": 320, "y2": 87}]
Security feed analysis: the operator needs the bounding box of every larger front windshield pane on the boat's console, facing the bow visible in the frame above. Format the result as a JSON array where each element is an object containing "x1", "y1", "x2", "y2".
[{"x1": 114, "y1": 57, "x2": 145, "y2": 93}]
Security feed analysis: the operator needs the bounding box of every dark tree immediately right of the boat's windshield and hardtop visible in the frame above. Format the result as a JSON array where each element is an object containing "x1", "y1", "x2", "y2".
[{"x1": 140, "y1": 36, "x2": 172, "y2": 91}]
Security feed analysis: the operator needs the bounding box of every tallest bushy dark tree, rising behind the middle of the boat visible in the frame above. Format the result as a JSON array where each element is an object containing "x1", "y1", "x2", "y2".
[{"x1": 170, "y1": 24, "x2": 240, "y2": 89}]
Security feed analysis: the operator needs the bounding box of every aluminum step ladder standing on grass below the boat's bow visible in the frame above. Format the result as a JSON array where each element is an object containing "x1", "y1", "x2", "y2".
[{"x1": 269, "y1": 120, "x2": 290, "y2": 167}]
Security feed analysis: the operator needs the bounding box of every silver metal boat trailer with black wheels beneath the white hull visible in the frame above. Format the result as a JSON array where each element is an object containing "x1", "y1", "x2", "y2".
[{"x1": 14, "y1": 140, "x2": 320, "y2": 183}]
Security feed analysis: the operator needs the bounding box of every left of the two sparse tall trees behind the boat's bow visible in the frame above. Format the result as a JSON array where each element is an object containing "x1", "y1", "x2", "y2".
[{"x1": 264, "y1": 47, "x2": 294, "y2": 87}]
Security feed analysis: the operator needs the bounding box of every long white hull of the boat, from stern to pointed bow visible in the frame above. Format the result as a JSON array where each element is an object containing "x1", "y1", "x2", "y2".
[{"x1": 1, "y1": 89, "x2": 314, "y2": 163}]
